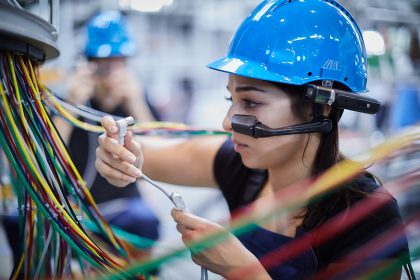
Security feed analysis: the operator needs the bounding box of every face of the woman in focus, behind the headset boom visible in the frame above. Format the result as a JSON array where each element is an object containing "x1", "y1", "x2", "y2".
[{"x1": 223, "y1": 75, "x2": 309, "y2": 169}]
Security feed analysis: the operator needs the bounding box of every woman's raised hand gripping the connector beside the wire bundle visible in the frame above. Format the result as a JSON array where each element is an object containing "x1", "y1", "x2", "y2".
[{"x1": 95, "y1": 116, "x2": 143, "y2": 187}]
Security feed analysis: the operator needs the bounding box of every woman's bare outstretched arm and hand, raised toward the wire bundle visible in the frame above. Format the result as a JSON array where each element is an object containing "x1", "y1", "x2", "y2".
[{"x1": 95, "y1": 116, "x2": 225, "y2": 187}]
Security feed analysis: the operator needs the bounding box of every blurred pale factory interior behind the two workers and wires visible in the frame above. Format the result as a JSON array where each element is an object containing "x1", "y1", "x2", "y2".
[{"x1": 0, "y1": 0, "x2": 420, "y2": 279}]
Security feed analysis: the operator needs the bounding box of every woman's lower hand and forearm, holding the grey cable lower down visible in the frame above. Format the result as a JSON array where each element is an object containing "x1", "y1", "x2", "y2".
[{"x1": 171, "y1": 208, "x2": 271, "y2": 279}]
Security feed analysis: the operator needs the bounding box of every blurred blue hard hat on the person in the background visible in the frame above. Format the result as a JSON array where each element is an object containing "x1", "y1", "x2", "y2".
[{"x1": 84, "y1": 11, "x2": 136, "y2": 58}]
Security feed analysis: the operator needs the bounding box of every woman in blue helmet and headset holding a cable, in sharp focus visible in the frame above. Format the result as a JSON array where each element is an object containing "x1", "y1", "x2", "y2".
[{"x1": 95, "y1": 0, "x2": 408, "y2": 279}]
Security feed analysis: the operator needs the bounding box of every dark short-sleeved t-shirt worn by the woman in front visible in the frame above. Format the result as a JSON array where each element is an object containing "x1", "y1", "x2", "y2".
[{"x1": 214, "y1": 139, "x2": 408, "y2": 279}]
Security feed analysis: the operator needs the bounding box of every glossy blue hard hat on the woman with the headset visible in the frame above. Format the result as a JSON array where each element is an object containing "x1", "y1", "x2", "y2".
[{"x1": 208, "y1": 0, "x2": 367, "y2": 92}]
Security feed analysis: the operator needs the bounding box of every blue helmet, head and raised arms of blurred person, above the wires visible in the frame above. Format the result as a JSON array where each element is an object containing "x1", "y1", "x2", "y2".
[{"x1": 60, "y1": 10, "x2": 153, "y2": 123}]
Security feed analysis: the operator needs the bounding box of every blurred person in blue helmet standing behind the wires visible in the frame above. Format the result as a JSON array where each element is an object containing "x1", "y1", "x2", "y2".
[{"x1": 56, "y1": 11, "x2": 159, "y2": 247}]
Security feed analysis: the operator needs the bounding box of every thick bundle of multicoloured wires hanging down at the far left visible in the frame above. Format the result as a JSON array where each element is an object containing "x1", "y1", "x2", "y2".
[{"x1": 0, "y1": 51, "x2": 143, "y2": 279}]
